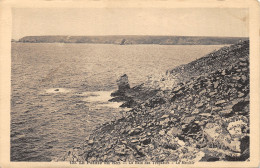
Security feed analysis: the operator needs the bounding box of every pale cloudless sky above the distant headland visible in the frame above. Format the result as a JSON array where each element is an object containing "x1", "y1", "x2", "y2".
[{"x1": 12, "y1": 8, "x2": 248, "y2": 39}]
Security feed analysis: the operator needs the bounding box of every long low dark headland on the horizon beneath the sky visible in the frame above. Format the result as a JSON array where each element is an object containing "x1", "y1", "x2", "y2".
[{"x1": 15, "y1": 35, "x2": 249, "y2": 45}]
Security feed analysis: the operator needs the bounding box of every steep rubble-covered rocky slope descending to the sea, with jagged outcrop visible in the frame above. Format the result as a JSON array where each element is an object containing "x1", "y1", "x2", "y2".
[{"x1": 59, "y1": 41, "x2": 250, "y2": 163}]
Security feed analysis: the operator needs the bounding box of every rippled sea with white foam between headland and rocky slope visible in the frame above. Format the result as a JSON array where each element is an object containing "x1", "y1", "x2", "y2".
[{"x1": 11, "y1": 43, "x2": 223, "y2": 161}]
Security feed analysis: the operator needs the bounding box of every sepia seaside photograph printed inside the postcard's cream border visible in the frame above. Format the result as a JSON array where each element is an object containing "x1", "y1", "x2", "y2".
[{"x1": 0, "y1": 0, "x2": 259, "y2": 166}]
